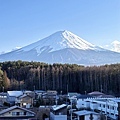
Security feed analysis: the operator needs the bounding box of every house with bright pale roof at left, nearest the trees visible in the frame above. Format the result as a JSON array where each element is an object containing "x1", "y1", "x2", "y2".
[{"x1": 7, "y1": 91, "x2": 23, "y2": 104}]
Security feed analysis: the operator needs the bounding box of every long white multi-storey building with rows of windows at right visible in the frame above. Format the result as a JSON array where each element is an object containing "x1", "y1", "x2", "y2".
[{"x1": 76, "y1": 98, "x2": 120, "y2": 119}]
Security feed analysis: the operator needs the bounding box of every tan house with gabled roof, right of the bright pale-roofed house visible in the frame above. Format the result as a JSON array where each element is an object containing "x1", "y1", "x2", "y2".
[{"x1": 15, "y1": 94, "x2": 33, "y2": 108}]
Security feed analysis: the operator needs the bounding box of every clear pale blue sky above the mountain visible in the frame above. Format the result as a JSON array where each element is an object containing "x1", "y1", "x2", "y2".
[{"x1": 0, "y1": 0, "x2": 120, "y2": 52}]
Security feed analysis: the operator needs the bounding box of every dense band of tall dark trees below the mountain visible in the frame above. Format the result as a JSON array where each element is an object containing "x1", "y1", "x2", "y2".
[{"x1": 0, "y1": 61, "x2": 120, "y2": 95}]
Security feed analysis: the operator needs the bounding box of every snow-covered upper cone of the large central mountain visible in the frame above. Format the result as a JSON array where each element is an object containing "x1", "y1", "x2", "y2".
[{"x1": 22, "y1": 30, "x2": 96, "y2": 54}]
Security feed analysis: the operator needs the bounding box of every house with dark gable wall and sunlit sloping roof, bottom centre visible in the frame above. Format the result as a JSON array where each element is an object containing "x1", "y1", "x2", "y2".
[{"x1": 50, "y1": 104, "x2": 67, "y2": 120}]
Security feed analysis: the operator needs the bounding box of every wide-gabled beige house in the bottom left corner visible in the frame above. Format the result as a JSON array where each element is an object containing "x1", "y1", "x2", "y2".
[{"x1": 0, "y1": 106, "x2": 35, "y2": 120}]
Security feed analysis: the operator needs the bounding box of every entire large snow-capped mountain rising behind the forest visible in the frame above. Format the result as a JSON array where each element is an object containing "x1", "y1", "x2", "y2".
[{"x1": 0, "y1": 30, "x2": 120, "y2": 65}]
